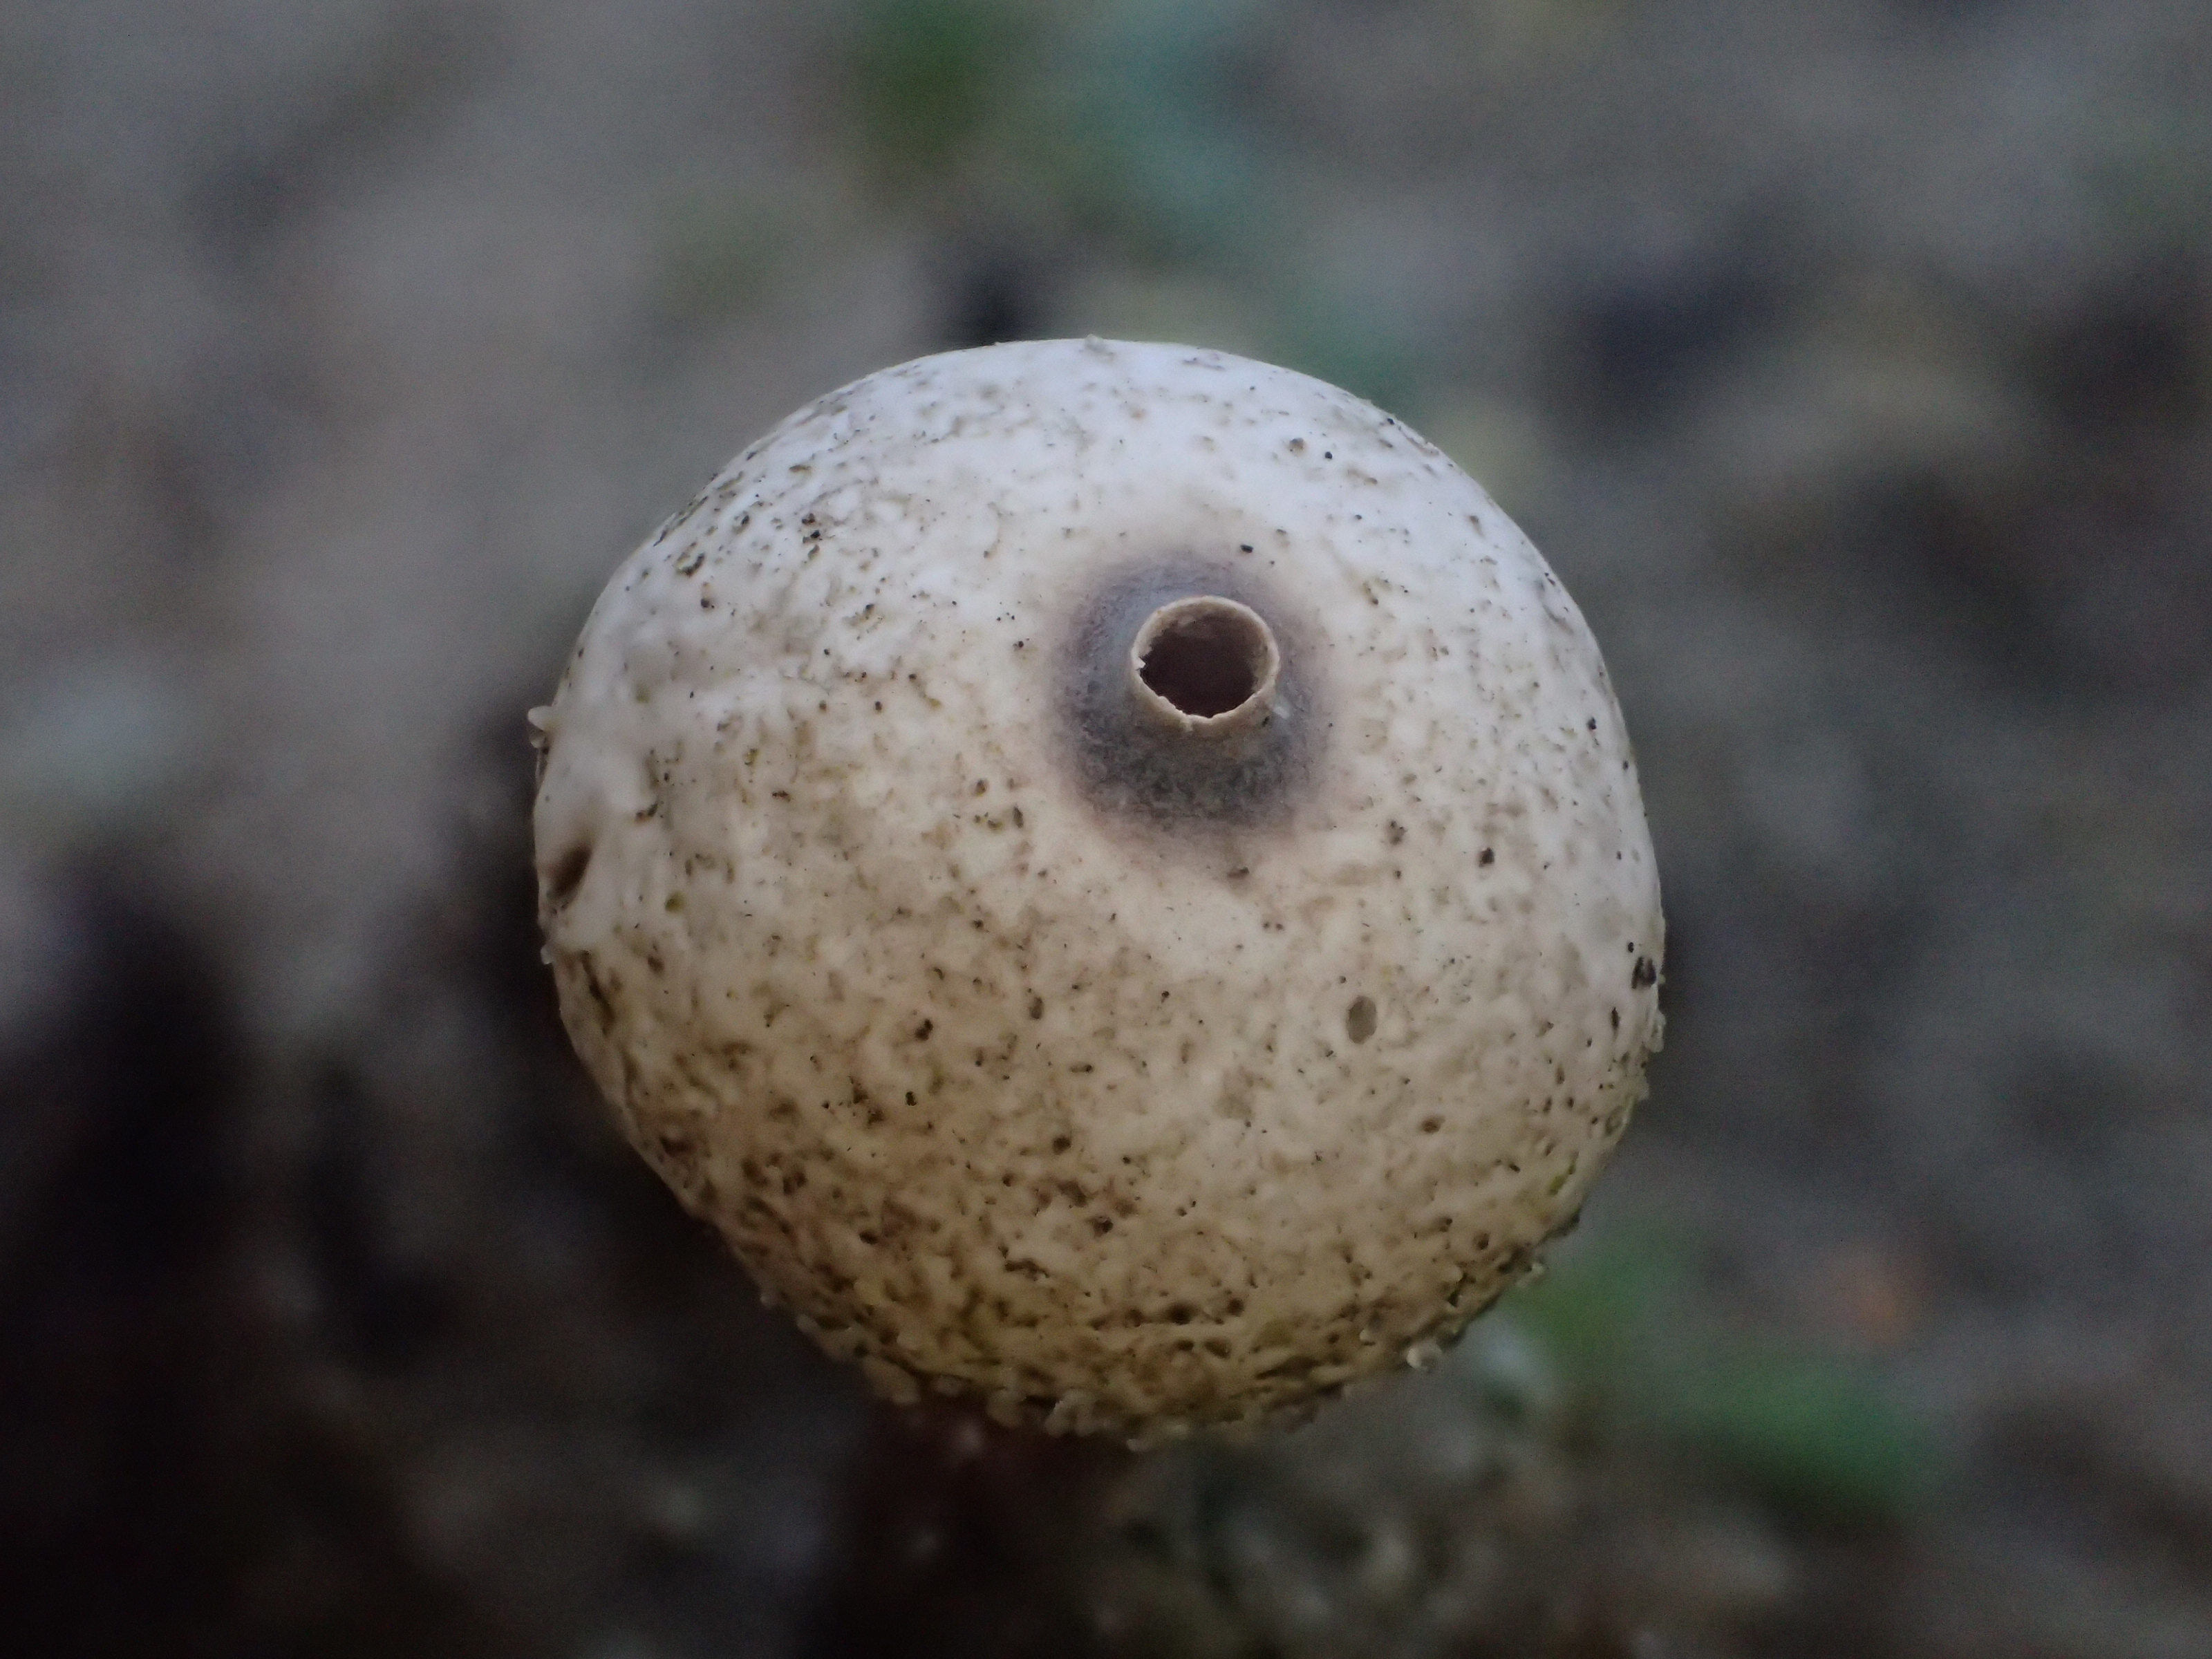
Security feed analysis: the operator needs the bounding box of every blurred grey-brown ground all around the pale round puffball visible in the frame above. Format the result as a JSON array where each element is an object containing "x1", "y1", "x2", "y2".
[{"x1": 0, "y1": 0, "x2": 2212, "y2": 1659}]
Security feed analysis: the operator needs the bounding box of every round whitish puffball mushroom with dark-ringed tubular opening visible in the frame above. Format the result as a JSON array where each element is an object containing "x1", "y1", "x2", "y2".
[{"x1": 533, "y1": 339, "x2": 1661, "y2": 1438}]
